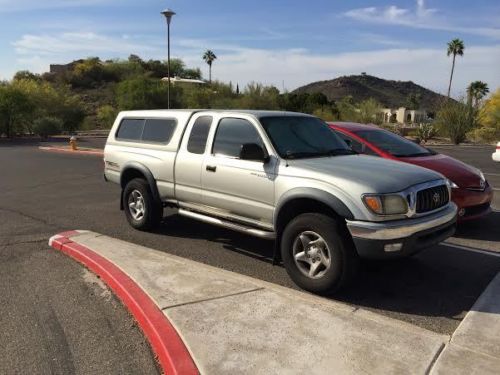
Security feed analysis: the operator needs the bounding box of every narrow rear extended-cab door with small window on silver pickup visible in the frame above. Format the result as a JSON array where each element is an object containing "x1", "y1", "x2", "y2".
[{"x1": 175, "y1": 114, "x2": 213, "y2": 204}]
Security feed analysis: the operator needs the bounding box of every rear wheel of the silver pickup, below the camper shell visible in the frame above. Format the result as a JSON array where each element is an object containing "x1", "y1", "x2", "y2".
[{"x1": 123, "y1": 178, "x2": 162, "y2": 231}]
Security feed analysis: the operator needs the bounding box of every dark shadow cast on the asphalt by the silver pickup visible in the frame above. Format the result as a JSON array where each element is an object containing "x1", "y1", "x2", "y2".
[{"x1": 153, "y1": 215, "x2": 500, "y2": 333}]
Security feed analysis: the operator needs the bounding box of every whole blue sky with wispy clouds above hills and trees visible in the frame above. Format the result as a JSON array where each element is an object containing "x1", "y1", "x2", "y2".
[{"x1": 0, "y1": 0, "x2": 500, "y2": 97}]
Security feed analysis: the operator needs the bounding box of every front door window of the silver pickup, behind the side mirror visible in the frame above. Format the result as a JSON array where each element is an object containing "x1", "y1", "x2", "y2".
[{"x1": 213, "y1": 118, "x2": 264, "y2": 158}]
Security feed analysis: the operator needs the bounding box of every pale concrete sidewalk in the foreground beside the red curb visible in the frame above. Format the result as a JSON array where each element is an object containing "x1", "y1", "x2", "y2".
[{"x1": 47, "y1": 232, "x2": 500, "y2": 374}]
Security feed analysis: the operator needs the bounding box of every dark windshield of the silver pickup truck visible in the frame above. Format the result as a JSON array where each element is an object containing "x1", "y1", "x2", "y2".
[{"x1": 260, "y1": 116, "x2": 355, "y2": 159}]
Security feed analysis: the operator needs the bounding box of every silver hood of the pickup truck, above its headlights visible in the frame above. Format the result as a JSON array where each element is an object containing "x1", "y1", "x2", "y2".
[{"x1": 280, "y1": 155, "x2": 443, "y2": 193}]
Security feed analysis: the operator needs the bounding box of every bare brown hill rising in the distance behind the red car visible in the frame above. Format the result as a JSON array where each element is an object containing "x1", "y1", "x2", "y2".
[{"x1": 293, "y1": 74, "x2": 446, "y2": 111}]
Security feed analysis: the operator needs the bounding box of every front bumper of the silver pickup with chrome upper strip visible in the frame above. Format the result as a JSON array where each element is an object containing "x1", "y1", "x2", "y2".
[{"x1": 347, "y1": 203, "x2": 457, "y2": 258}]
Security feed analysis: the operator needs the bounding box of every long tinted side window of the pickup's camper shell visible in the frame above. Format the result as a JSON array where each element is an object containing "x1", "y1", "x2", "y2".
[{"x1": 116, "y1": 119, "x2": 177, "y2": 144}]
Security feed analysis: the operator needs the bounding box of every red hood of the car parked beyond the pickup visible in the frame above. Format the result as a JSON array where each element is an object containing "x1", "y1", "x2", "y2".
[{"x1": 399, "y1": 154, "x2": 481, "y2": 189}]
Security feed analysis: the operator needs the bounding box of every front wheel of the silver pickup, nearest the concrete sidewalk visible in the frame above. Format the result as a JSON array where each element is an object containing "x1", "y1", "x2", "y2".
[{"x1": 281, "y1": 213, "x2": 358, "y2": 294}]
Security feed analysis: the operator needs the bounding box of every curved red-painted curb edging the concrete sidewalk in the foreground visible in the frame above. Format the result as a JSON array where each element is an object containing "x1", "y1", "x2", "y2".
[{"x1": 49, "y1": 231, "x2": 199, "y2": 375}]
